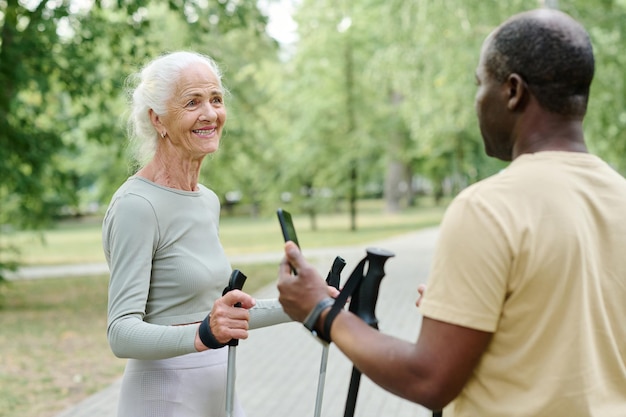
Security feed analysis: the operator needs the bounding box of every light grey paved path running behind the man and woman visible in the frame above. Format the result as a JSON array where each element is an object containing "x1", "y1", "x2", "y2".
[{"x1": 57, "y1": 228, "x2": 437, "y2": 417}]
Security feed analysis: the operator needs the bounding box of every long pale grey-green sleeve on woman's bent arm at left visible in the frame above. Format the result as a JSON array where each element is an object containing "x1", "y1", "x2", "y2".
[{"x1": 103, "y1": 194, "x2": 197, "y2": 360}]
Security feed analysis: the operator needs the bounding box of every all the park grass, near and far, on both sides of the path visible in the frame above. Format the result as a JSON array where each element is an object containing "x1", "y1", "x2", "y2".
[{"x1": 0, "y1": 201, "x2": 443, "y2": 417}]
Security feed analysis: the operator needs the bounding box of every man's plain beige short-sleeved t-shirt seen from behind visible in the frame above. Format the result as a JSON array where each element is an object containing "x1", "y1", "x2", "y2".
[{"x1": 420, "y1": 152, "x2": 626, "y2": 417}]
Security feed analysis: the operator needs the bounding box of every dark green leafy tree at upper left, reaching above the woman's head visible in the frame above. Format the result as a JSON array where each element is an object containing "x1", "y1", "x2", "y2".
[{"x1": 0, "y1": 0, "x2": 278, "y2": 279}]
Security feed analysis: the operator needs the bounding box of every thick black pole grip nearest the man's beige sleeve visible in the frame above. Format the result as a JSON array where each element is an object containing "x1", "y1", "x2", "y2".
[{"x1": 350, "y1": 248, "x2": 395, "y2": 328}]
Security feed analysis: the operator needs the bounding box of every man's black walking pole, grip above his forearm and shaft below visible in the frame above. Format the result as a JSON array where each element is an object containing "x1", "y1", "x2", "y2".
[{"x1": 344, "y1": 248, "x2": 395, "y2": 417}]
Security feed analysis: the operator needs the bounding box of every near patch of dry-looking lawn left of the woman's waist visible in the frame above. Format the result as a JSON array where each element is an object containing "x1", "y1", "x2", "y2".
[{"x1": 0, "y1": 276, "x2": 124, "y2": 417}]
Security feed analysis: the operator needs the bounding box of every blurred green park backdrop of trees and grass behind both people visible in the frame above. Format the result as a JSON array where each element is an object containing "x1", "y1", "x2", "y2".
[{"x1": 0, "y1": 0, "x2": 626, "y2": 417}]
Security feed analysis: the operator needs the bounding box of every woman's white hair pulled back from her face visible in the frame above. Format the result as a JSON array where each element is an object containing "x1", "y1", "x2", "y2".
[{"x1": 126, "y1": 51, "x2": 224, "y2": 166}]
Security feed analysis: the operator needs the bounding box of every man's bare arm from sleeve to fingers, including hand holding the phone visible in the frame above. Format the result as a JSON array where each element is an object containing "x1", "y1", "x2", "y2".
[{"x1": 278, "y1": 243, "x2": 491, "y2": 410}]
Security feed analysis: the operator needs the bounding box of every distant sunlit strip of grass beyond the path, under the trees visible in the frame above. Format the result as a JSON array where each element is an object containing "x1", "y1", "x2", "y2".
[{"x1": 2, "y1": 200, "x2": 443, "y2": 265}]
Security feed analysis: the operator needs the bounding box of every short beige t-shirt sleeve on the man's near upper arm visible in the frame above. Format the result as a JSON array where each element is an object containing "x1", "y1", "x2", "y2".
[{"x1": 420, "y1": 195, "x2": 511, "y2": 332}]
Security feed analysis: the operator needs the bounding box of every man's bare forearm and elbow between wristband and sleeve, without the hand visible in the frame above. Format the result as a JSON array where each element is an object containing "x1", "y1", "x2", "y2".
[{"x1": 320, "y1": 311, "x2": 491, "y2": 410}]
